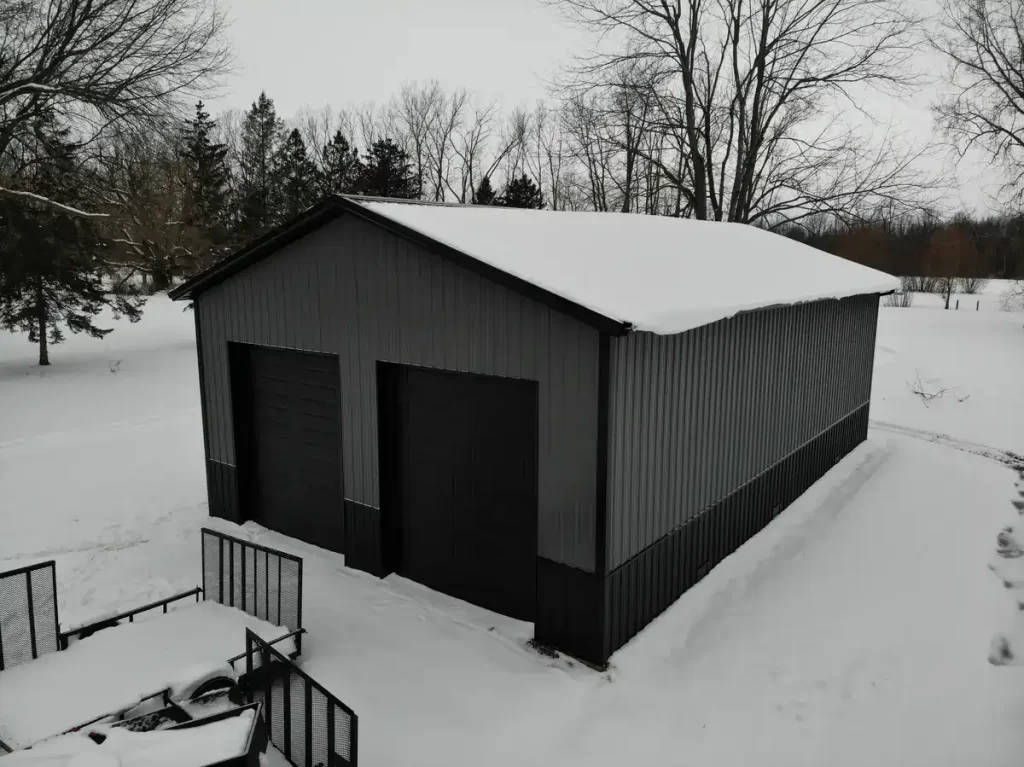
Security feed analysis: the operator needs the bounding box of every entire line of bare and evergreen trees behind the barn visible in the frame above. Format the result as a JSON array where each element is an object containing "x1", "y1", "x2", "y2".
[{"x1": 6, "y1": 0, "x2": 1024, "y2": 361}]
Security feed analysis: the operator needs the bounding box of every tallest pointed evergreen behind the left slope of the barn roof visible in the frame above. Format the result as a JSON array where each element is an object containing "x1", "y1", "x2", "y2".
[{"x1": 238, "y1": 92, "x2": 284, "y2": 240}]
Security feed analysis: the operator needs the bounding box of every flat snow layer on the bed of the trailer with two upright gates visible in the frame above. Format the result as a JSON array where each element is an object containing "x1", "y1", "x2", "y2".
[{"x1": 0, "y1": 601, "x2": 296, "y2": 749}]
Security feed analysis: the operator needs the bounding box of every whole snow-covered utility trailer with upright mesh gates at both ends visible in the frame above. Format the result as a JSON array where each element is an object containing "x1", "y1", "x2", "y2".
[{"x1": 0, "y1": 528, "x2": 303, "y2": 753}]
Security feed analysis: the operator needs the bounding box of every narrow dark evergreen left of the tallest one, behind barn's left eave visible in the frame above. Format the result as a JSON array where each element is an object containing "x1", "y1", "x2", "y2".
[{"x1": 181, "y1": 101, "x2": 230, "y2": 249}]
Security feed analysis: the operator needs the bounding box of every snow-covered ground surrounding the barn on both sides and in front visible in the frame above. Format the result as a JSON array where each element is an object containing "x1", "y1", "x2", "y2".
[{"x1": 0, "y1": 297, "x2": 1024, "y2": 767}]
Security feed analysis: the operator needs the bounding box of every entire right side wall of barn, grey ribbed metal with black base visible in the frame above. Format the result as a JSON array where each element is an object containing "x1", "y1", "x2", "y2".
[{"x1": 600, "y1": 295, "x2": 879, "y2": 657}]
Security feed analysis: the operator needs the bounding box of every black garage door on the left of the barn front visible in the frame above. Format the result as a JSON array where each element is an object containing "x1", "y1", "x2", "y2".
[{"x1": 234, "y1": 347, "x2": 343, "y2": 551}]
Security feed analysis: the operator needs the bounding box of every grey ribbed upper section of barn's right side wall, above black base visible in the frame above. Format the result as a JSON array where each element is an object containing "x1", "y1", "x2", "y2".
[{"x1": 607, "y1": 296, "x2": 878, "y2": 568}]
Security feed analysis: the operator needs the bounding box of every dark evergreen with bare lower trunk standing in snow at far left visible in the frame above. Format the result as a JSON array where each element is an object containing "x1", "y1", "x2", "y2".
[{"x1": 0, "y1": 120, "x2": 143, "y2": 365}]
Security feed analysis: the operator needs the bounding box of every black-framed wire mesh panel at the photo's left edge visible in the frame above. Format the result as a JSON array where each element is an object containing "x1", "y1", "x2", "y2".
[{"x1": 0, "y1": 560, "x2": 59, "y2": 671}]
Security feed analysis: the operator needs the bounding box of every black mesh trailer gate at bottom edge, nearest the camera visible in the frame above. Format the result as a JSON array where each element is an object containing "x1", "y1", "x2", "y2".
[{"x1": 244, "y1": 629, "x2": 359, "y2": 767}]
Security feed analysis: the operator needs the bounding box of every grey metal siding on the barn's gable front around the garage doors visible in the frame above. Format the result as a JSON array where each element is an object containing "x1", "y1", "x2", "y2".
[{"x1": 196, "y1": 215, "x2": 599, "y2": 571}]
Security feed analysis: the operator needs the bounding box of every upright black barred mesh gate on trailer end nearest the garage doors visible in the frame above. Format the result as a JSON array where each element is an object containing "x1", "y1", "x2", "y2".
[{"x1": 203, "y1": 527, "x2": 302, "y2": 652}]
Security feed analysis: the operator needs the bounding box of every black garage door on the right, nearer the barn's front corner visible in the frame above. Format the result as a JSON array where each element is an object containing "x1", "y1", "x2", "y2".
[{"x1": 381, "y1": 366, "x2": 537, "y2": 621}]
